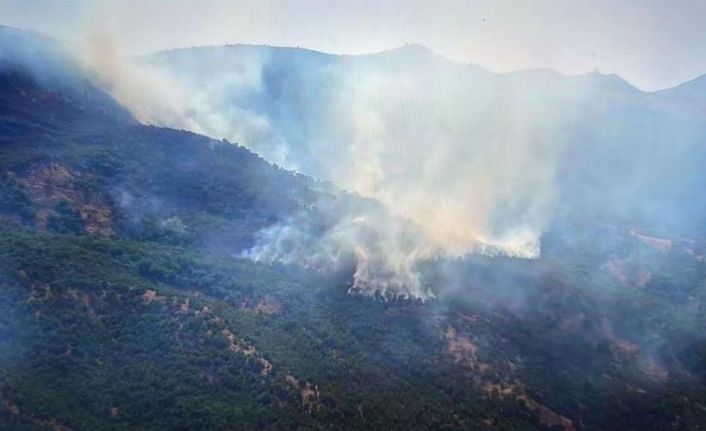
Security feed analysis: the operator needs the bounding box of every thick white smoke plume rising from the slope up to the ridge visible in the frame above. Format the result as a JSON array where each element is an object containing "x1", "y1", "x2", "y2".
[{"x1": 77, "y1": 44, "x2": 584, "y2": 298}]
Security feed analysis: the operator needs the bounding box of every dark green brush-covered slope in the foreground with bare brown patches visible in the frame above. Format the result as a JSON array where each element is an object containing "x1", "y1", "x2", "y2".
[{"x1": 0, "y1": 27, "x2": 706, "y2": 430}]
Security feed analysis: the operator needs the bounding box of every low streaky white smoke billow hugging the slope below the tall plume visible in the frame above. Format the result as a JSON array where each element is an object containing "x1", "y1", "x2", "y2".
[{"x1": 244, "y1": 194, "x2": 441, "y2": 300}]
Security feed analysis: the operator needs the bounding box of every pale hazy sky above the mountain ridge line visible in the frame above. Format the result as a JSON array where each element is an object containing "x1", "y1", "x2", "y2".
[{"x1": 0, "y1": 0, "x2": 706, "y2": 90}]
